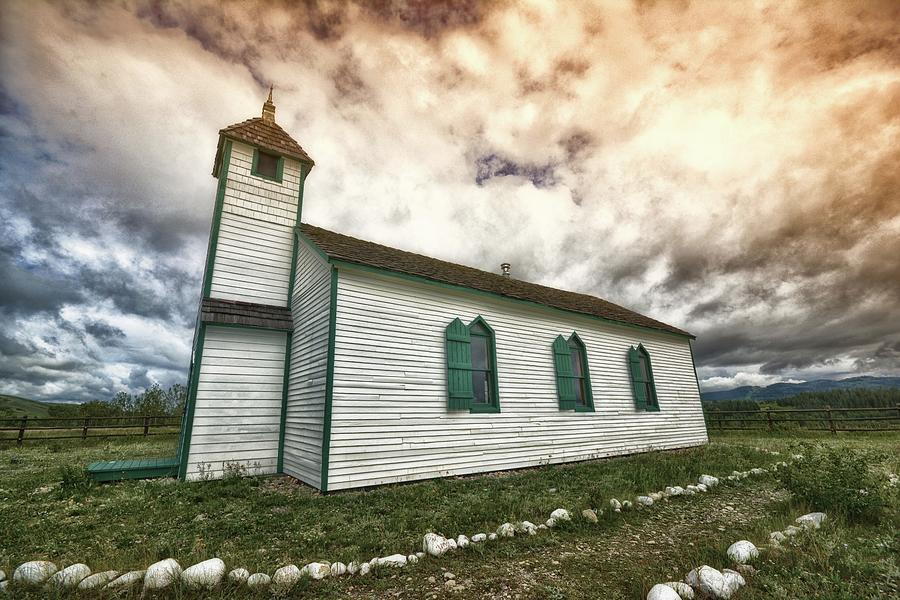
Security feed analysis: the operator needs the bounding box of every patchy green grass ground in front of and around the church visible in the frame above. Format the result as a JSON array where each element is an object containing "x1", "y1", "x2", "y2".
[{"x1": 0, "y1": 434, "x2": 900, "y2": 599}]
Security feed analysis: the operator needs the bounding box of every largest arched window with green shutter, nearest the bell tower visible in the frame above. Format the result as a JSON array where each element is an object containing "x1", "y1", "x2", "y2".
[{"x1": 446, "y1": 317, "x2": 500, "y2": 412}]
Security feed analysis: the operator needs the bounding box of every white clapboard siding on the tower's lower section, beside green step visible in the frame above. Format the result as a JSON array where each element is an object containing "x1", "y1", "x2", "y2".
[{"x1": 181, "y1": 325, "x2": 287, "y2": 479}]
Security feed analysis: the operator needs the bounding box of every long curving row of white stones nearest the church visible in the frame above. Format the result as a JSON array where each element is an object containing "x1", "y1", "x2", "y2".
[{"x1": 0, "y1": 458, "x2": 799, "y2": 592}]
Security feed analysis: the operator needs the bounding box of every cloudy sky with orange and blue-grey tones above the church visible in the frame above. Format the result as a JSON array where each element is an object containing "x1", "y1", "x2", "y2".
[{"x1": 0, "y1": 0, "x2": 900, "y2": 400}]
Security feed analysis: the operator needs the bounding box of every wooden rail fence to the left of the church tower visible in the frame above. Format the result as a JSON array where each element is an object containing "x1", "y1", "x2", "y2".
[{"x1": 0, "y1": 415, "x2": 181, "y2": 446}]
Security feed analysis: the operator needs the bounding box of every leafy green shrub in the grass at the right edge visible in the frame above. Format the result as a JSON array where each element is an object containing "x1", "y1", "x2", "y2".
[{"x1": 777, "y1": 444, "x2": 889, "y2": 521}]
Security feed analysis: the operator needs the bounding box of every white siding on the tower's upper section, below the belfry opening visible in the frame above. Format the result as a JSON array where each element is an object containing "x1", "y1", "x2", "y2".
[{"x1": 210, "y1": 142, "x2": 300, "y2": 306}]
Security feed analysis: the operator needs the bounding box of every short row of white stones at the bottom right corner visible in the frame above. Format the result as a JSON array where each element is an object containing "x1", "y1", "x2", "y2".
[{"x1": 647, "y1": 512, "x2": 826, "y2": 600}]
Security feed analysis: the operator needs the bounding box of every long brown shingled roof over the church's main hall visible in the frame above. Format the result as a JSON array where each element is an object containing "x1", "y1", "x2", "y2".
[{"x1": 299, "y1": 223, "x2": 694, "y2": 338}]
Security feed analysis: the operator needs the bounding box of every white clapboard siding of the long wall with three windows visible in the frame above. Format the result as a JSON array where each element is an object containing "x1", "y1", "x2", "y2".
[{"x1": 328, "y1": 268, "x2": 707, "y2": 490}]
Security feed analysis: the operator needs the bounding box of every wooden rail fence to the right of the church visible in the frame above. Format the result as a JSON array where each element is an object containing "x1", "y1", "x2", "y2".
[{"x1": 704, "y1": 404, "x2": 900, "y2": 433}]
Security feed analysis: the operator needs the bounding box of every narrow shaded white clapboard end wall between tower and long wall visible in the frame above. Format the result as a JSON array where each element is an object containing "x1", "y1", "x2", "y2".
[{"x1": 283, "y1": 242, "x2": 331, "y2": 488}]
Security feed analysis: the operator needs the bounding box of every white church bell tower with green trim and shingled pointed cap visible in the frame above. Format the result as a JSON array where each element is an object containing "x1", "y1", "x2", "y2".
[{"x1": 178, "y1": 88, "x2": 313, "y2": 479}]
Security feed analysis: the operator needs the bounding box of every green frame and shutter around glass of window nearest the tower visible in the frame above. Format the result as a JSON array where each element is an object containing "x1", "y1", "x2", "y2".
[{"x1": 444, "y1": 316, "x2": 500, "y2": 413}]
